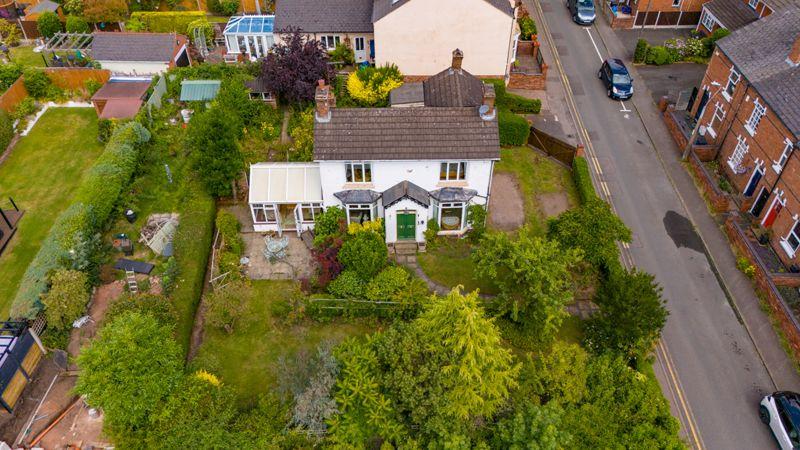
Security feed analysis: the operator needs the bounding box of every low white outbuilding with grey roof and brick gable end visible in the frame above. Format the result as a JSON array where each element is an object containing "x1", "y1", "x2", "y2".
[{"x1": 91, "y1": 32, "x2": 192, "y2": 75}]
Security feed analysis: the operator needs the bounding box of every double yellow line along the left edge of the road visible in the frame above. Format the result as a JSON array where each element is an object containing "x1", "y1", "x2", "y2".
[{"x1": 532, "y1": 0, "x2": 705, "y2": 450}]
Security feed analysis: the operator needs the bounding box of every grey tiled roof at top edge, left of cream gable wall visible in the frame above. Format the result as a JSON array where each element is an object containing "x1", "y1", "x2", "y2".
[{"x1": 275, "y1": 0, "x2": 373, "y2": 33}]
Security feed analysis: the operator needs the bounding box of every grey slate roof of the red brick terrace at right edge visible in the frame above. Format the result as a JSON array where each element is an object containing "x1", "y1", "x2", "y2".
[{"x1": 717, "y1": 6, "x2": 800, "y2": 138}]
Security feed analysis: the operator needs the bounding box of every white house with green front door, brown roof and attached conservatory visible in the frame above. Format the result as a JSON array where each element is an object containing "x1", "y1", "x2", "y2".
[{"x1": 250, "y1": 50, "x2": 500, "y2": 244}]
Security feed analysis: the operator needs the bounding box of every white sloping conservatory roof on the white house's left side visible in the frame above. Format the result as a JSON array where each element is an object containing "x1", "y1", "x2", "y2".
[{"x1": 249, "y1": 163, "x2": 322, "y2": 204}]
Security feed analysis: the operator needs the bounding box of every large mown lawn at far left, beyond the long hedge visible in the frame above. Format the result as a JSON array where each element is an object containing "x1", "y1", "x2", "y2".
[{"x1": 0, "y1": 108, "x2": 103, "y2": 317}]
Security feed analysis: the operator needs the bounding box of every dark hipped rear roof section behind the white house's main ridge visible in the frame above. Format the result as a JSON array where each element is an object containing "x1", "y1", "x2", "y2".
[{"x1": 423, "y1": 68, "x2": 483, "y2": 107}]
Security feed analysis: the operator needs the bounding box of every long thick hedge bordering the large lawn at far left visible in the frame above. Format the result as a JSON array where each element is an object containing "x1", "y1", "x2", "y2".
[{"x1": 11, "y1": 122, "x2": 150, "y2": 319}]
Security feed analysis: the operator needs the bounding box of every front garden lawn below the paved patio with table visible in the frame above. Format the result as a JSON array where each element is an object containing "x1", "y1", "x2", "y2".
[{"x1": 192, "y1": 280, "x2": 374, "y2": 404}]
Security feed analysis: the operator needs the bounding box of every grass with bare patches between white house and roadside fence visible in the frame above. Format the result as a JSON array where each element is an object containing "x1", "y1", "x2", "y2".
[{"x1": 495, "y1": 147, "x2": 578, "y2": 234}]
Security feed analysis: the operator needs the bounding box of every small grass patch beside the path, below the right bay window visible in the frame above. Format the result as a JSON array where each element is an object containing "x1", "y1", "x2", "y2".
[{"x1": 417, "y1": 238, "x2": 498, "y2": 295}]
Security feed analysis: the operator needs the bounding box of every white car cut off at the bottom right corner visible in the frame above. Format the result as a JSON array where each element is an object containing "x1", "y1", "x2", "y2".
[{"x1": 758, "y1": 391, "x2": 800, "y2": 450}]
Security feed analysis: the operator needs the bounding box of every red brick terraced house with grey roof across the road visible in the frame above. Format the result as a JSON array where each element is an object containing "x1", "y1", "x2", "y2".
[{"x1": 691, "y1": 6, "x2": 800, "y2": 266}]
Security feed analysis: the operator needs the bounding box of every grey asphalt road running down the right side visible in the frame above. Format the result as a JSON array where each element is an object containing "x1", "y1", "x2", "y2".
[{"x1": 540, "y1": 0, "x2": 776, "y2": 449}]
